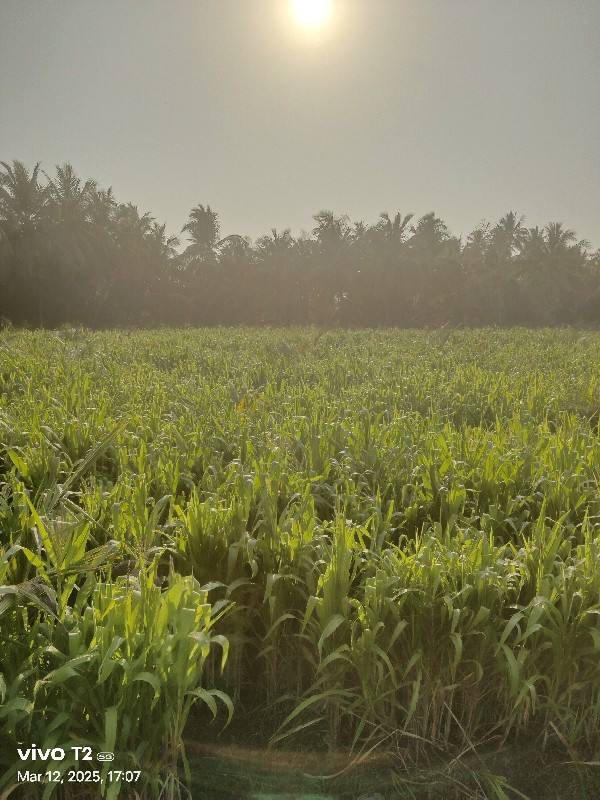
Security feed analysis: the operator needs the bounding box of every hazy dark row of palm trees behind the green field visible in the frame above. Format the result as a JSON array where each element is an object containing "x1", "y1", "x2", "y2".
[{"x1": 0, "y1": 161, "x2": 600, "y2": 327}]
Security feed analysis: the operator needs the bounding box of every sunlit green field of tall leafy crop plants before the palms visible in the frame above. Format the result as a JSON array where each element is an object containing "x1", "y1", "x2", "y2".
[{"x1": 0, "y1": 328, "x2": 600, "y2": 800}]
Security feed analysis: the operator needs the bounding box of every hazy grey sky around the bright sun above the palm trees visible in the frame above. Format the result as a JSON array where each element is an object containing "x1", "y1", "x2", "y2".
[{"x1": 0, "y1": 0, "x2": 600, "y2": 247}]
